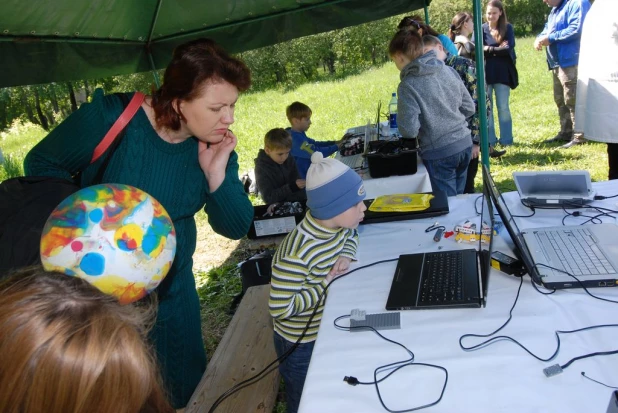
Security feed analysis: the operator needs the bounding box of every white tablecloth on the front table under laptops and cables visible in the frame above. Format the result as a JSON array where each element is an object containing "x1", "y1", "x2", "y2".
[{"x1": 300, "y1": 182, "x2": 618, "y2": 413}]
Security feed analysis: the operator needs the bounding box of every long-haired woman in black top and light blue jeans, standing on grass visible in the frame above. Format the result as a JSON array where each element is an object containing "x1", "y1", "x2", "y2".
[{"x1": 483, "y1": 0, "x2": 519, "y2": 146}]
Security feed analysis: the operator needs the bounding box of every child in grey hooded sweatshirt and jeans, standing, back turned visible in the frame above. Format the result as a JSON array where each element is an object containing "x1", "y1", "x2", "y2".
[{"x1": 389, "y1": 29, "x2": 475, "y2": 196}]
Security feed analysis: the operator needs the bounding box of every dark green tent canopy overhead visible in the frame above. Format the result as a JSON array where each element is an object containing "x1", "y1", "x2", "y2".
[{"x1": 0, "y1": 0, "x2": 431, "y2": 87}]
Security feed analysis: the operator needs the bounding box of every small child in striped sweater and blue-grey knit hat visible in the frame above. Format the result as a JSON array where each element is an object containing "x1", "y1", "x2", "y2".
[{"x1": 269, "y1": 152, "x2": 367, "y2": 413}]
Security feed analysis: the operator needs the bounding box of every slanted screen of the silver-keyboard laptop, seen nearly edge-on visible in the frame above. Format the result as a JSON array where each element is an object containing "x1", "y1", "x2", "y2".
[{"x1": 483, "y1": 165, "x2": 541, "y2": 284}]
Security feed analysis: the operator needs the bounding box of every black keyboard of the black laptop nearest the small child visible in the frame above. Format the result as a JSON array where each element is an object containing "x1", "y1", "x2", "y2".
[{"x1": 419, "y1": 251, "x2": 463, "y2": 305}]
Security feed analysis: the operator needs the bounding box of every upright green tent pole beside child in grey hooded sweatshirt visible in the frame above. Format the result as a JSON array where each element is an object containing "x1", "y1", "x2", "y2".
[{"x1": 472, "y1": 0, "x2": 489, "y2": 168}]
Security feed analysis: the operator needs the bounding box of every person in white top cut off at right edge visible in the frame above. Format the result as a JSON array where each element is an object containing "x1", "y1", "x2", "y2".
[{"x1": 574, "y1": 0, "x2": 618, "y2": 175}]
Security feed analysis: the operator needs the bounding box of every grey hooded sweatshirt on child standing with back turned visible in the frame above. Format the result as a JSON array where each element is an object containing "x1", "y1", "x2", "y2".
[{"x1": 397, "y1": 50, "x2": 475, "y2": 160}]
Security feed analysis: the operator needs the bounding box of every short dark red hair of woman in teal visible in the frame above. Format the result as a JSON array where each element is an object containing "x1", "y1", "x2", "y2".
[{"x1": 152, "y1": 39, "x2": 251, "y2": 130}]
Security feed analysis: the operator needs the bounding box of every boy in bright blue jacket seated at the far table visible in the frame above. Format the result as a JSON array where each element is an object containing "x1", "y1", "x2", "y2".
[{"x1": 285, "y1": 102, "x2": 344, "y2": 179}]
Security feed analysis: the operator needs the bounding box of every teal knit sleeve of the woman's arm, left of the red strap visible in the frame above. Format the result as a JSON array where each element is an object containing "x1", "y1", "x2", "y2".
[{"x1": 24, "y1": 89, "x2": 123, "y2": 179}]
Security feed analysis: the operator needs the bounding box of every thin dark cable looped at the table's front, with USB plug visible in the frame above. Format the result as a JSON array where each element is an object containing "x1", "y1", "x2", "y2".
[{"x1": 333, "y1": 314, "x2": 448, "y2": 413}]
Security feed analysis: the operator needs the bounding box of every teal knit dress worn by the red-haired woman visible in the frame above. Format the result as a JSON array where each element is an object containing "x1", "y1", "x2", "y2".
[{"x1": 24, "y1": 90, "x2": 253, "y2": 408}]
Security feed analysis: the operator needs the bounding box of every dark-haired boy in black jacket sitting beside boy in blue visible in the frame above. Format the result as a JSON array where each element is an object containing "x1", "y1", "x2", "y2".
[{"x1": 255, "y1": 128, "x2": 307, "y2": 204}]
